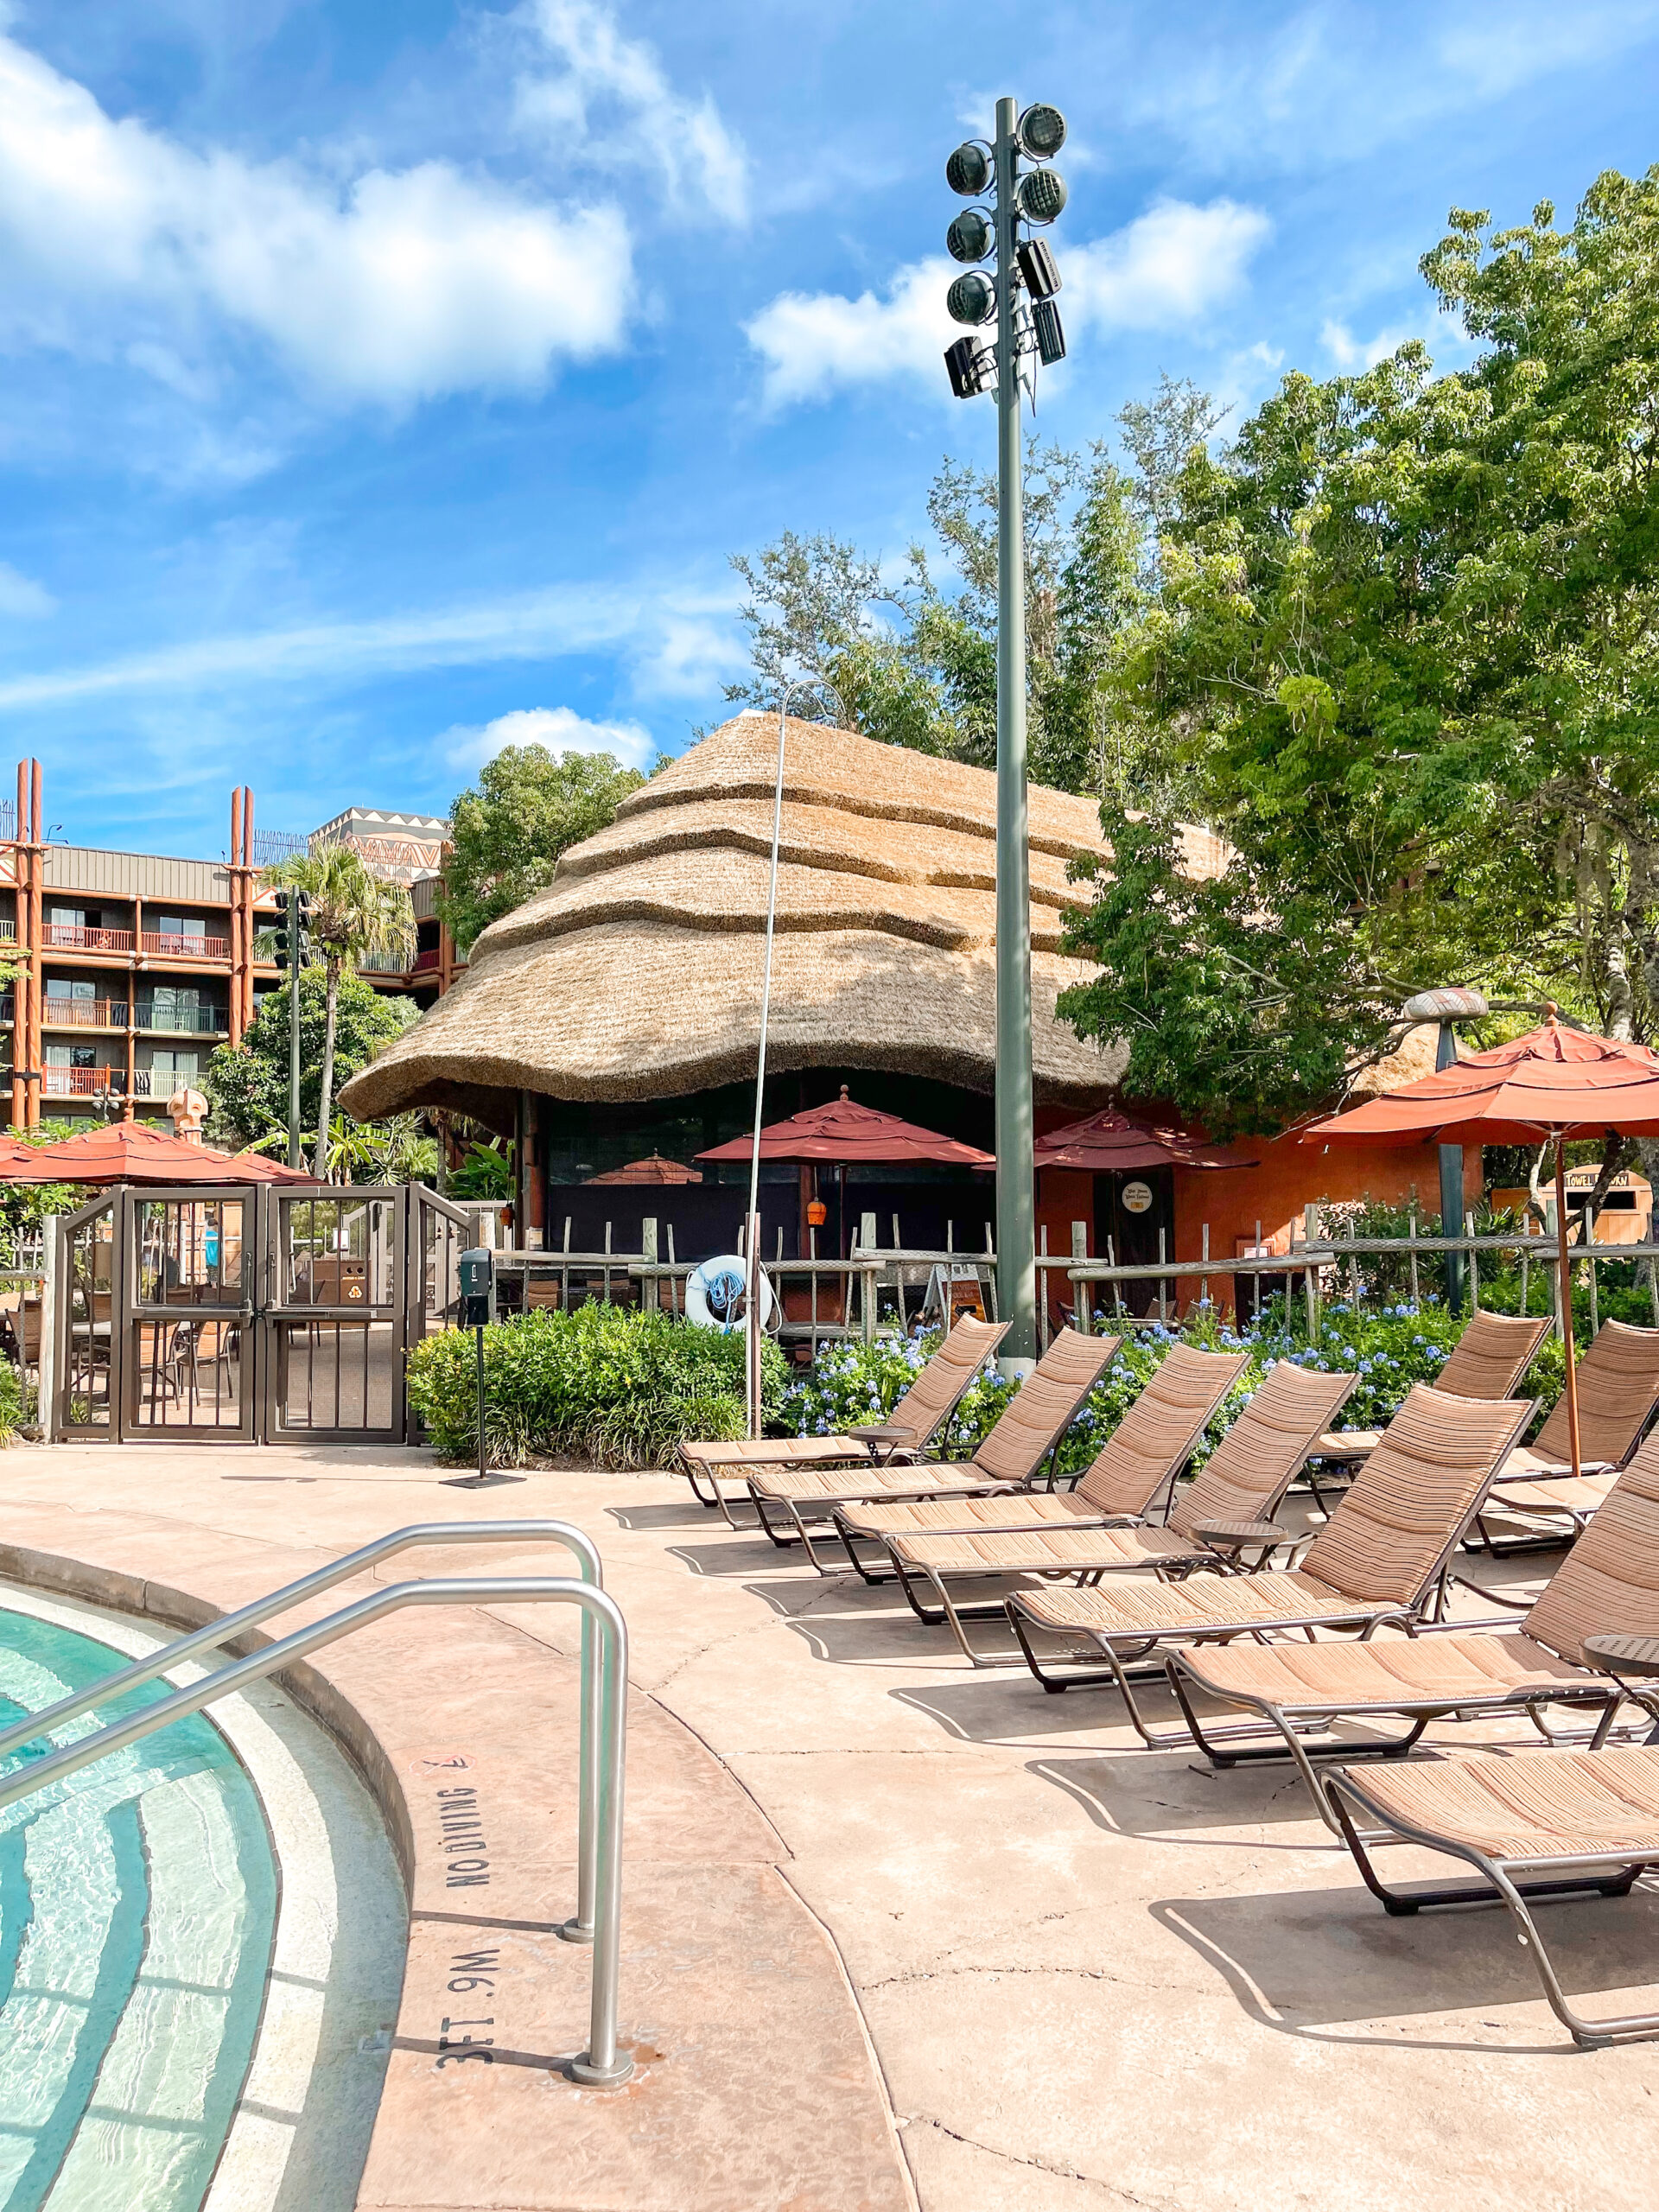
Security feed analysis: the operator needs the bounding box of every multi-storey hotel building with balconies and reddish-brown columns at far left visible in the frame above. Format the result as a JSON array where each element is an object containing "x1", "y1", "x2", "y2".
[{"x1": 0, "y1": 761, "x2": 462, "y2": 1128}]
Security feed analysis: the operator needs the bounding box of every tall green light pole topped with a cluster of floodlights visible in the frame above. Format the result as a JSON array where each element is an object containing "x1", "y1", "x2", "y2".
[{"x1": 944, "y1": 99, "x2": 1066, "y2": 1374}]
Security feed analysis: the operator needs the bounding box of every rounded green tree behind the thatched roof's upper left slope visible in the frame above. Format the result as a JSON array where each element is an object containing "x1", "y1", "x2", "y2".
[{"x1": 440, "y1": 746, "x2": 646, "y2": 951}]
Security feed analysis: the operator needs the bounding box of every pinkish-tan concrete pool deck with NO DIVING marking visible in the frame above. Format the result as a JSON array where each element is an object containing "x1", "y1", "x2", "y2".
[{"x1": 0, "y1": 1446, "x2": 1659, "y2": 2212}]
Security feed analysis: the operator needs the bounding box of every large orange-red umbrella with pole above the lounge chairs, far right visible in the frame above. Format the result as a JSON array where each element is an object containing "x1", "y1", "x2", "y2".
[{"x1": 1303, "y1": 1008, "x2": 1659, "y2": 1476}]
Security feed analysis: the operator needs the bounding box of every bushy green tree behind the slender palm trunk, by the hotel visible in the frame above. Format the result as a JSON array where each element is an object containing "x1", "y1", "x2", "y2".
[{"x1": 206, "y1": 967, "x2": 420, "y2": 1150}]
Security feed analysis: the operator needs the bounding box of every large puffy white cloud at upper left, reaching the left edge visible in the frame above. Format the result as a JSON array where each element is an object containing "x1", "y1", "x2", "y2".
[{"x1": 0, "y1": 38, "x2": 632, "y2": 407}]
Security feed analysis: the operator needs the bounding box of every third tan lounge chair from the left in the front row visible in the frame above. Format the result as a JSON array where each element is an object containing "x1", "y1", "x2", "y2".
[{"x1": 834, "y1": 1344, "x2": 1256, "y2": 1583}]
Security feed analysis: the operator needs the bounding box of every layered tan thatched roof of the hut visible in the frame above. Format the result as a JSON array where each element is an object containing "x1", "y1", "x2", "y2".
[{"x1": 340, "y1": 715, "x2": 1167, "y2": 1119}]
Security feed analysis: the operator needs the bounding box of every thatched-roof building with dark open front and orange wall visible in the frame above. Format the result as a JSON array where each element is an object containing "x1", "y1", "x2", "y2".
[{"x1": 340, "y1": 712, "x2": 1480, "y2": 1292}]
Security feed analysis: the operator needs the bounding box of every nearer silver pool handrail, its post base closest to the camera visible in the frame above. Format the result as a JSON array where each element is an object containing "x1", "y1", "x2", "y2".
[{"x1": 0, "y1": 1575, "x2": 632, "y2": 2088}]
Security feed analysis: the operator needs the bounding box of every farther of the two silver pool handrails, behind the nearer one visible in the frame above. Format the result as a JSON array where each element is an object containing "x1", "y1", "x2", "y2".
[{"x1": 0, "y1": 1520, "x2": 604, "y2": 1942}]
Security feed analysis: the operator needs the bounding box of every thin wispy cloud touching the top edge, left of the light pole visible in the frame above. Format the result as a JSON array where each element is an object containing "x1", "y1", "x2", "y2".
[{"x1": 513, "y1": 0, "x2": 747, "y2": 224}]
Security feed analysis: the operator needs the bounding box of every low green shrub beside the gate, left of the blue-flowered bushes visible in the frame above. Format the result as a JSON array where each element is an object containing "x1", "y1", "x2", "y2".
[{"x1": 410, "y1": 1305, "x2": 785, "y2": 1466}]
